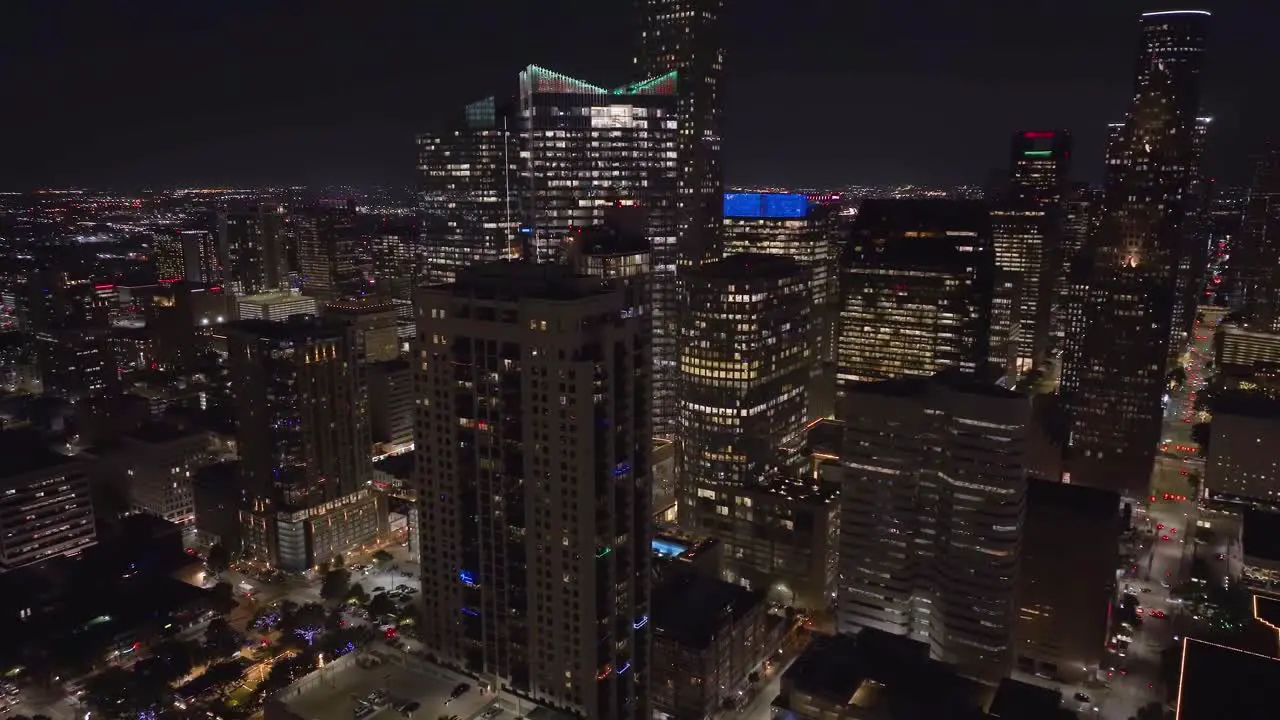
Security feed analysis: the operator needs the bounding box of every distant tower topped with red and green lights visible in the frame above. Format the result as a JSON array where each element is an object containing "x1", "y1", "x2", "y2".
[{"x1": 991, "y1": 131, "x2": 1071, "y2": 375}]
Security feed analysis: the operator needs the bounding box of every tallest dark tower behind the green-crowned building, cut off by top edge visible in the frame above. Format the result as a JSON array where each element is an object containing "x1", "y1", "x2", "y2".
[{"x1": 636, "y1": 0, "x2": 724, "y2": 265}]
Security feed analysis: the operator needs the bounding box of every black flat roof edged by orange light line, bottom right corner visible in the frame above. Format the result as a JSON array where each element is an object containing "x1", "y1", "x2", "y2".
[{"x1": 1176, "y1": 638, "x2": 1280, "y2": 720}]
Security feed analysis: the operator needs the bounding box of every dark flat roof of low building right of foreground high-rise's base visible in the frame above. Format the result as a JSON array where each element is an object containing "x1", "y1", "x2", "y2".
[{"x1": 653, "y1": 574, "x2": 765, "y2": 648}]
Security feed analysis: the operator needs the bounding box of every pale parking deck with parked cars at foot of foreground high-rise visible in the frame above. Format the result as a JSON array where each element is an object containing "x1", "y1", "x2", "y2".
[{"x1": 287, "y1": 662, "x2": 495, "y2": 720}]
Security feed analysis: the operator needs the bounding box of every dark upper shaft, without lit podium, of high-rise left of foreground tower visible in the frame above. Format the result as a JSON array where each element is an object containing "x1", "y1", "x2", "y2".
[{"x1": 225, "y1": 316, "x2": 370, "y2": 509}]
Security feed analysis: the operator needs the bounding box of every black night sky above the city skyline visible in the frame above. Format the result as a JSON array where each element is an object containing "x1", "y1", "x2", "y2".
[{"x1": 0, "y1": 0, "x2": 1280, "y2": 190}]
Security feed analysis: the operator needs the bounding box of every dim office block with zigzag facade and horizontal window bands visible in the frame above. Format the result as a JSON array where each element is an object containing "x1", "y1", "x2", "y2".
[{"x1": 837, "y1": 369, "x2": 1030, "y2": 678}]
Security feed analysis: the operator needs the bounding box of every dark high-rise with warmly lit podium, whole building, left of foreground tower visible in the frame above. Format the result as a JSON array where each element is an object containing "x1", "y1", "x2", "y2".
[{"x1": 225, "y1": 316, "x2": 387, "y2": 571}]
